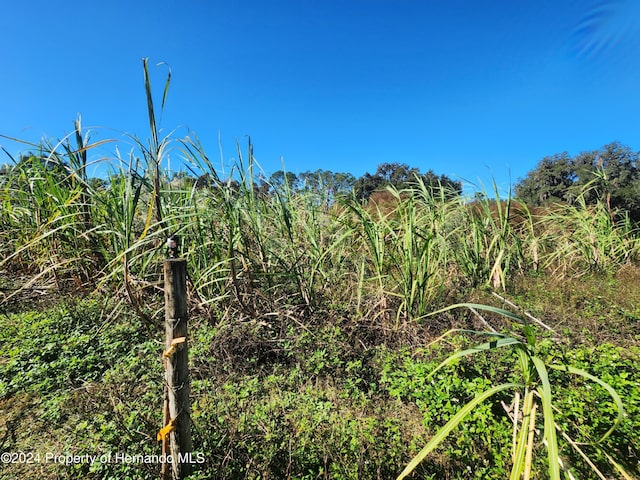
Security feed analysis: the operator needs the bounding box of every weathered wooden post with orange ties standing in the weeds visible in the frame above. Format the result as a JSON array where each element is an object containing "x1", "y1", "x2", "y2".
[{"x1": 159, "y1": 258, "x2": 193, "y2": 480}]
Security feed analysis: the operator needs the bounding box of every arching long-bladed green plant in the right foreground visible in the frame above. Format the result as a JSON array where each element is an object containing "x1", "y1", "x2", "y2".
[{"x1": 398, "y1": 303, "x2": 626, "y2": 480}]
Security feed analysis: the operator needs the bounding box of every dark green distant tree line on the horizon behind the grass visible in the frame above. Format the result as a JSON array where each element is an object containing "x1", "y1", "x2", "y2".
[{"x1": 0, "y1": 142, "x2": 640, "y2": 221}]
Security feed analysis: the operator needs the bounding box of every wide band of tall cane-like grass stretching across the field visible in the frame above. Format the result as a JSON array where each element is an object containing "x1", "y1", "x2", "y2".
[{"x1": 0, "y1": 60, "x2": 640, "y2": 322}]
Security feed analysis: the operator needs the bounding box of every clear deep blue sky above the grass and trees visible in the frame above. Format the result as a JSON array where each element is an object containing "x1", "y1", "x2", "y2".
[{"x1": 0, "y1": 0, "x2": 640, "y2": 193}]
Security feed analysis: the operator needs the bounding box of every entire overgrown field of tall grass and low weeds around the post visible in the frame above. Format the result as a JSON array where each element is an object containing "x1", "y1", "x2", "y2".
[{"x1": 0, "y1": 69, "x2": 640, "y2": 480}]
